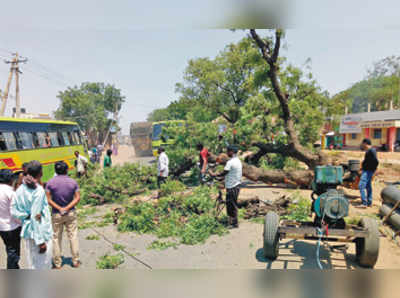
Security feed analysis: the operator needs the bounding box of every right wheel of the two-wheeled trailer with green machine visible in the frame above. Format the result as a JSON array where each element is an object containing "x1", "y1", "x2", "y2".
[{"x1": 356, "y1": 217, "x2": 379, "y2": 268}]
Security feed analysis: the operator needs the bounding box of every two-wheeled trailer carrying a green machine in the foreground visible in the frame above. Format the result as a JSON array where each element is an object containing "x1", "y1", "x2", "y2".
[{"x1": 263, "y1": 160, "x2": 379, "y2": 268}]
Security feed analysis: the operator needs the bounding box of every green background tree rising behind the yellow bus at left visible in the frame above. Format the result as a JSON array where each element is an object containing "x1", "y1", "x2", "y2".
[{"x1": 55, "y1": 83, "x2": 125, "y2": 145}]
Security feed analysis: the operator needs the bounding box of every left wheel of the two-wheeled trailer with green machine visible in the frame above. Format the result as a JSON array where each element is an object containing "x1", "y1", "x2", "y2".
[{"x1": 264, "y1": 211, "x2": 279, "y2": 260}]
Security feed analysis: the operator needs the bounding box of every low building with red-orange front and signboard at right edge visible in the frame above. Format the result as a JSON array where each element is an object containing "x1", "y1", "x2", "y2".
[{"x1": 339, "y1": 110, "x2": 400, "y2": 152}]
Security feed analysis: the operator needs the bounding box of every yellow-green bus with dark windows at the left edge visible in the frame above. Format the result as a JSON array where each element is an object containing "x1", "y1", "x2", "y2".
[{"x1": 0, "y1": 117, "x2": 87, "y2": 182}]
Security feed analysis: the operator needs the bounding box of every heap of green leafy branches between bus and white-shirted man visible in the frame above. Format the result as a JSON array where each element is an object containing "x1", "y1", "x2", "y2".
[{"x1": 78, "y1": 163, "x2": 157, "y2": 205}]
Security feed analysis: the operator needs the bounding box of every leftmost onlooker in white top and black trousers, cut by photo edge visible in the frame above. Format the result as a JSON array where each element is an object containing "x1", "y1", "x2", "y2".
[{"x1": 0, "y1": 169, "x2": 21, "y2": 269}]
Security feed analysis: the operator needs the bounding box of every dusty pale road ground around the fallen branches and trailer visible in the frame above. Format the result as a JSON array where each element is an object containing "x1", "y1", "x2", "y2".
[{"x1": 0, "y1": 146, "x2": 400, "y2": 270}]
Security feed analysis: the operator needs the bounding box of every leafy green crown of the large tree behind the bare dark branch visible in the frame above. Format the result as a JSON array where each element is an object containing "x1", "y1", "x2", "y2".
[{"x1": 149, "y1": 36, "x2": 328, "y2": 173}]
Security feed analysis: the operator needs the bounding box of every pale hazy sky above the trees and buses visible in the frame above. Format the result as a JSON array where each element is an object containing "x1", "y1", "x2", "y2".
[{"x1": 0, "y1": 0, "x2": 400, "y2": 134}]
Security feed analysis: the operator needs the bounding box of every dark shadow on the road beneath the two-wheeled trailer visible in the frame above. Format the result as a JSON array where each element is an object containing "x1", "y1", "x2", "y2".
[{"x1": 255, "y1": 240, "x2": 358, "y2": 269}]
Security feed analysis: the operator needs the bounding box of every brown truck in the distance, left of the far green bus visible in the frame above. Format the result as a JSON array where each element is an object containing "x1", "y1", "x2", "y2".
[{"x1": 130, "y1": 122, "x2": 153, "y2": 157}]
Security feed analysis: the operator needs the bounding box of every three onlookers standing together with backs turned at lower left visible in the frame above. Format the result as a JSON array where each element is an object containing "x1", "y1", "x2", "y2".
[{"x1": 0, "y1": 159, "x2": 81, "y2": 269}]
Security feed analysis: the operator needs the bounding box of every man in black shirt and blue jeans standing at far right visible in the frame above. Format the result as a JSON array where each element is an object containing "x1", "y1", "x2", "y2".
[{"x1": 358, "y1": 139, "x2": 379, "y2": 208}]
